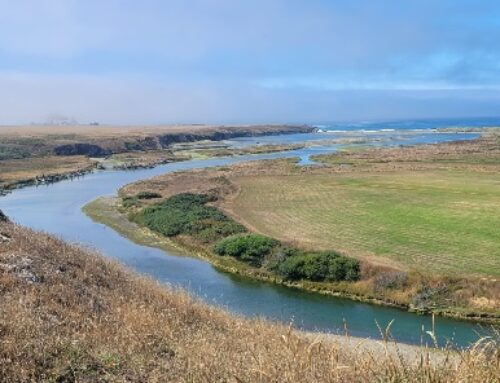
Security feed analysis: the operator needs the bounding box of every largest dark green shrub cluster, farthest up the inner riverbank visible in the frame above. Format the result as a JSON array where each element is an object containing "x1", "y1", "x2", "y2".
[{"x1": 136, "y1": 193, "x2": 246, "y2": 242}]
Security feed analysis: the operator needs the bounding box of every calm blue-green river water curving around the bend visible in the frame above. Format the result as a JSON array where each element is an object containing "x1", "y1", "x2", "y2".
[{"x1": 0, "y1": 131, "x2": 490, "y2": 346}]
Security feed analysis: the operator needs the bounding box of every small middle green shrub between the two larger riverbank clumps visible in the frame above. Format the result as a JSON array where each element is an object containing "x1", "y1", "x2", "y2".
[{"x1": 213, "y1": 234, "x2": 279, "y2": 266}]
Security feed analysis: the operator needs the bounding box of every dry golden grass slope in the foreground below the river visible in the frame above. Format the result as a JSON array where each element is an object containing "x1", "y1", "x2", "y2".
[{"x1": 0, "y1": 223, "x2": 500, "y2": 382}]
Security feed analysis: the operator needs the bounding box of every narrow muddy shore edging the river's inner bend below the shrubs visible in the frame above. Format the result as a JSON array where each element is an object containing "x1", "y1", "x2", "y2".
[{"x1": 82, "y1": 196, "x2": 500, "y2": 325}]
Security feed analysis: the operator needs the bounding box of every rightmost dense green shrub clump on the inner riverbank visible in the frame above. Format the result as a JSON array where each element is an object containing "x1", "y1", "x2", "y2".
[{"x1": 276, "y1": 252, "x2": 359, "y2": 281}]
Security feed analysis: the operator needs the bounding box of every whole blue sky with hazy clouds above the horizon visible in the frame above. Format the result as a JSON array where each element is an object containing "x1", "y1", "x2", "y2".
[{"x1": 0, "y1": 0, "x2": 500, "y2": 125}]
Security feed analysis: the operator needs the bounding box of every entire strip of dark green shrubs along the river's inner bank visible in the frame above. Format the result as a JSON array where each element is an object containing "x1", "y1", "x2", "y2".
[{"x1": 130, "y1": 193, "x2": 360, "y2": 281}]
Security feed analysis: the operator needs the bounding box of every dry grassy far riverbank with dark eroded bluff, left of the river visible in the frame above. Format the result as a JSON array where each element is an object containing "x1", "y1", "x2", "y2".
[{"x1": 0, "y1": 125, "x2": 315, "y2": 190}]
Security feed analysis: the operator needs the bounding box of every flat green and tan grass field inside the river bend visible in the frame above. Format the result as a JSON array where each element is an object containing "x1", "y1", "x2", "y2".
[{"x1": 228, "y1": 169, "x2": 500, "y2": 276}]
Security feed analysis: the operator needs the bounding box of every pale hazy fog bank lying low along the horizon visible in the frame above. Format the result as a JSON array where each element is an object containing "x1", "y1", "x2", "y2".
[{"x1": 0, "y1": 73, "x2": 500, "y2": 125}]
